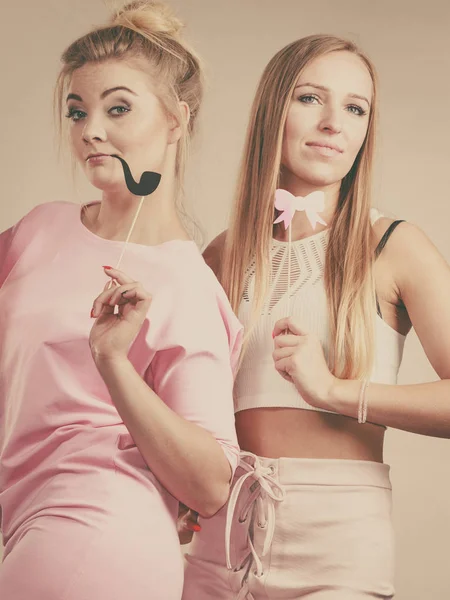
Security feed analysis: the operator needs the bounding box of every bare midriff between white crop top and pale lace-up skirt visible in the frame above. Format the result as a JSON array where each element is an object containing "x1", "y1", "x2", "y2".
[{"x1": 236, "y1": 408, "x2": 385, "y2": 462}]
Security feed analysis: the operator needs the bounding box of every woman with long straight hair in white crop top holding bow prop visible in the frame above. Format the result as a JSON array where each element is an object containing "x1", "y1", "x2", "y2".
[{"x1": 183, "y1": 35, "x2": 450, "y2": 600}]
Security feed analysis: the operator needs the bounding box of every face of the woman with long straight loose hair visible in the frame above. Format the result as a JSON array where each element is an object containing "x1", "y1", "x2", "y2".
[{"x1": 282, "y1": 51, "x2": 373, "y2": 191}]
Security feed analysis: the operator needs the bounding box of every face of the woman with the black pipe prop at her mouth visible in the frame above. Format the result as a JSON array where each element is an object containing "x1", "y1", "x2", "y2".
[{"x1": 67, "y1": 60, "x2": 180, "y2": 191}]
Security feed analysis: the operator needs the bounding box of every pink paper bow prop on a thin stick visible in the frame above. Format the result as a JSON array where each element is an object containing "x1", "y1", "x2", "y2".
[{"x1": 273, "y1": 190, "x2": 326, "y2": 317}]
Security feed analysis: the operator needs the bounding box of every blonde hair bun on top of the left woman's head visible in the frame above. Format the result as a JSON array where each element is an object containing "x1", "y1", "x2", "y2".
[{"x1": 112, "y1": 0, "x2": 184, "y2": 38}]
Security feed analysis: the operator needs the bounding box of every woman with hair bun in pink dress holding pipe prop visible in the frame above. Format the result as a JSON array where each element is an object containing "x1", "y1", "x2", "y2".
[{"x1": 0, "y1": 2, "x2": 242, "y2": 600}]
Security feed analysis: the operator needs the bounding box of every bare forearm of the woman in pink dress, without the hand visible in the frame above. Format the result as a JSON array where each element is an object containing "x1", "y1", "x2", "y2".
[{"x1": 96, "y1": 359, "x2": 231, "y2": 517}]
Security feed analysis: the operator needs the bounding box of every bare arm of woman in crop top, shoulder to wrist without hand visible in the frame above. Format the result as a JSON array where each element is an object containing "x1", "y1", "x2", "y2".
[{"x1": 323, "y1": 223, "x2": 450, "y2": 438}]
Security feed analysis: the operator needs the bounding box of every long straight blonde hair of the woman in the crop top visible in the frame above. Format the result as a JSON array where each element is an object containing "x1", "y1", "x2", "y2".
[{"x1": 220, "y1": 35, "x2": 377, "y2": 378}]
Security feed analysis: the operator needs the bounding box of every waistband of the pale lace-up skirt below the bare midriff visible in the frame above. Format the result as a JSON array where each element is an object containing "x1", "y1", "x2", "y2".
[{"x1": 235, "y1": 452, "x2": 392, "y2": 489}]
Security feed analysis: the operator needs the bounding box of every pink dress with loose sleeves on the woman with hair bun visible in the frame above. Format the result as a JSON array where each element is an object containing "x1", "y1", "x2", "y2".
[{"x1": 0, "y1": 202, "x2": 242, "y2": 600}]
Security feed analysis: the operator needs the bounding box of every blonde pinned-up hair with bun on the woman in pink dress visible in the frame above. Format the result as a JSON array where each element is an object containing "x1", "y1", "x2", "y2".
[{"x1": 55, "y1": 0, "x2": 203, "y2": 202}]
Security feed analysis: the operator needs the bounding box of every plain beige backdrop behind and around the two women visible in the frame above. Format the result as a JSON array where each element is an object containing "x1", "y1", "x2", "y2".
[{"x1": 0, "y1": 0, "x2": 450, "y2": 600}]
